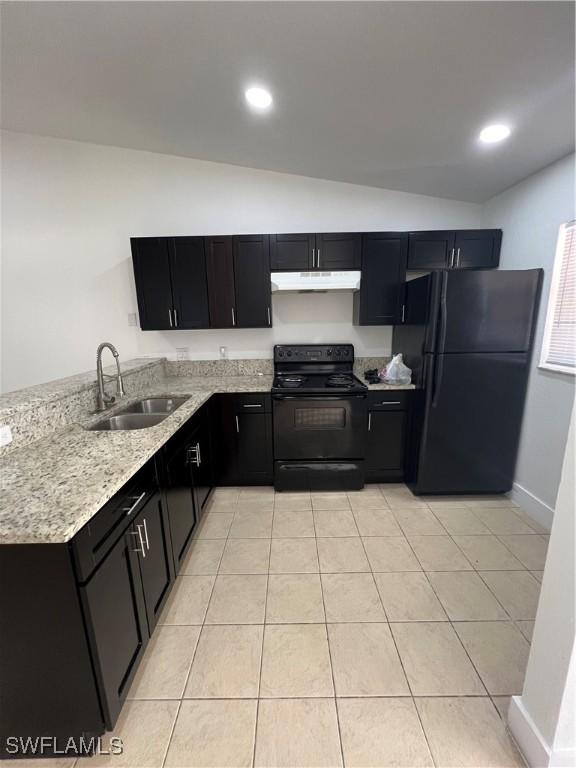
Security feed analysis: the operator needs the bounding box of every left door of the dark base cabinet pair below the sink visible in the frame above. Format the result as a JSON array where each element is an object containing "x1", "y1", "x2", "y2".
[{"x1": 165, "y1": 442, "x2": 196, "y2": 572}]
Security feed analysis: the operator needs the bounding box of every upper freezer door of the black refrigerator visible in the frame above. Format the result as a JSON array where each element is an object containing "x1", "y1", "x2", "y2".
[{"x1": 436, "y1": 269, "x2": 542, "y2": 353}]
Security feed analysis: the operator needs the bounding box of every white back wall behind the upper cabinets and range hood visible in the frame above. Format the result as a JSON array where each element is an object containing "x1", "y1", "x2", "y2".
[{"x1": 2, "y1": 132, "x2": 481, "y2": 391}]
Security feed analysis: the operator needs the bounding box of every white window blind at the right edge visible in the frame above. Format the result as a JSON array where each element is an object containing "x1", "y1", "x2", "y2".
[{"x1": 541, "y1": 221, "x2": 576, "y2": 373}]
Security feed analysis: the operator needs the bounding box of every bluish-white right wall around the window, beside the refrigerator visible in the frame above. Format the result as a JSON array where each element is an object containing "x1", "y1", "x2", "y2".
[{"x1": 483, "y1": 155, "x2": 575, "y2": 527}]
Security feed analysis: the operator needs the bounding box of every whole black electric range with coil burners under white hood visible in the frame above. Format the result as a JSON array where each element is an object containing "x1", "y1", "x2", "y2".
[{"x1": 272, "y1": 344, "x2": 368, "y2": 491}]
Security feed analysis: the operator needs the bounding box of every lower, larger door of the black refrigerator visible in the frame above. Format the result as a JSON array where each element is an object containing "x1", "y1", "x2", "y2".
[{"x1": 409, "y1": 353, "x2": 529, "y2": 494}]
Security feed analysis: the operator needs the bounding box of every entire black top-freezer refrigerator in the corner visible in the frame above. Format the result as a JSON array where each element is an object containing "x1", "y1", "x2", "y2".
[{"x1": 392, "y1": 269, "x2": 543, "y2": 494}]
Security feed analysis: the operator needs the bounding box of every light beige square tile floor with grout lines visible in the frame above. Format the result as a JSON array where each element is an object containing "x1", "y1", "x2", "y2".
[{"x1": 65, "y1": 484, "x2": 547, "y2": 768}]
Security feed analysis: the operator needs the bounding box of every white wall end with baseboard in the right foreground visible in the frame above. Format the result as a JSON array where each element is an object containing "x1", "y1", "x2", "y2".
[{"x1": 509, "y1": 404, "x2": 576, "y2": 768}]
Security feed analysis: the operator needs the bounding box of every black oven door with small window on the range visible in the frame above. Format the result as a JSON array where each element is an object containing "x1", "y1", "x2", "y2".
[{"x1": 273, "y1": 395, "x2": 367, "y2": 459}]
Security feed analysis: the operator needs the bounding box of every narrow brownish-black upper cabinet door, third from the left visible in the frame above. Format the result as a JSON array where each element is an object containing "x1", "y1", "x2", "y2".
[{"x1": 204, "y1": 237, "x2": 236, "y2": 328}]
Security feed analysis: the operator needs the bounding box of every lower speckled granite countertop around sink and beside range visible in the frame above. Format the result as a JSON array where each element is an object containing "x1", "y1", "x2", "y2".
[{"x1": 0, "y1": 375, "x2": 414, "y2": 544}]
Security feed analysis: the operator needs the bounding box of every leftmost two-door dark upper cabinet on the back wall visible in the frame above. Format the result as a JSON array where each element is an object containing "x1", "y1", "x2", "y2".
[{"x1": 131, "y1": 237, "x2": 209, "y2": 331}]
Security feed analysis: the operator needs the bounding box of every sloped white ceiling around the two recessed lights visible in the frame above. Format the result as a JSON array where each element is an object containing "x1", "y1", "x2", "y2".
[{"x1": 2, "y1": 2, "x2": 574, "y2": 202}]
